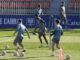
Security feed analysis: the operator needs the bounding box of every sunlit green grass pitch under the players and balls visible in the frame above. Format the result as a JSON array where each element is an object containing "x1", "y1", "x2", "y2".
[{"x1": 0, "y1": 28, "x2": 80, "y2": 60}]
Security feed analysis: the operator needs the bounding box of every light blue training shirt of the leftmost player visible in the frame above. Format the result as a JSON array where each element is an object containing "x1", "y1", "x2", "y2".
[{"x1": 14, "y1": 23, "x2": 29, "y2": 37}]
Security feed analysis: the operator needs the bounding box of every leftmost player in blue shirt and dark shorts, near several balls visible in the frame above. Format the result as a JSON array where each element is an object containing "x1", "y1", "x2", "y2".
[{"x1": 13, "y1": 20, "x2": 30, "y2": 52}]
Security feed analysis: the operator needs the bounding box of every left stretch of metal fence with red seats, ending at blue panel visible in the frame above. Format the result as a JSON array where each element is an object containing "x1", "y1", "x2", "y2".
[{"x1": 0, "y1": 0, "x2": 51, "y2": 14}]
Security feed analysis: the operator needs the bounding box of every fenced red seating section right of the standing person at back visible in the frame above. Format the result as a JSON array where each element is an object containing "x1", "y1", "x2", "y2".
[{"x1": 67, "y1": 0, "x2": 80, "y2": 15}]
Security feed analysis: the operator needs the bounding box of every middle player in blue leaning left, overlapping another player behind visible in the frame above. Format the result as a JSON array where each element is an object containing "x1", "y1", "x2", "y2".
[{"x1": 35, "y1": 14, "x2": 49, "y2": 47}]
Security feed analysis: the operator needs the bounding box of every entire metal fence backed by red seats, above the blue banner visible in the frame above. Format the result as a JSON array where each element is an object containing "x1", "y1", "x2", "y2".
[{"x1": 0, "y1": 0, "x2": 80, "y2": 15}]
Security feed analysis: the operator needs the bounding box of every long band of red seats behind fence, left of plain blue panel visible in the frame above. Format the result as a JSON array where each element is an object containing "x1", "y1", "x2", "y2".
[{"x1": 0, "y1": 0, "x2": 51, "y2": 9}]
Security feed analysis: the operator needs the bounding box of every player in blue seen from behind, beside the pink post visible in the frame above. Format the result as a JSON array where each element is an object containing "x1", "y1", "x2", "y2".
[{"x1": 51, "y1": 19, "x2": 63, "y2": 56}]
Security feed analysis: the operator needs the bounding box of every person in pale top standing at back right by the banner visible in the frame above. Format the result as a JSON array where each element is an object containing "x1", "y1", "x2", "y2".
[{"x1": 60, "y1": 1, "x2": 67, "y2": 28}]
